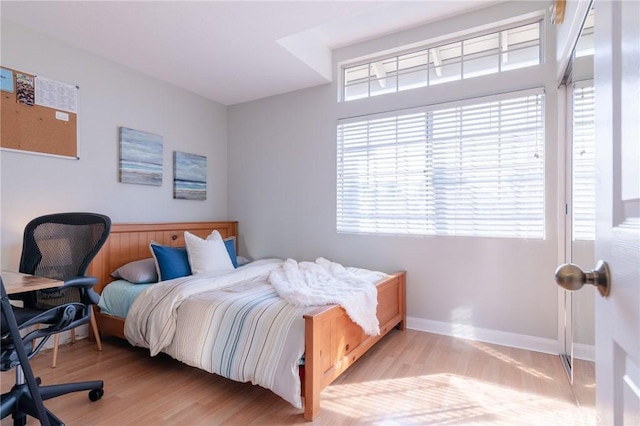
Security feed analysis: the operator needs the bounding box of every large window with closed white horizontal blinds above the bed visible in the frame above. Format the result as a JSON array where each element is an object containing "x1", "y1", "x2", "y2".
[{"x1": 337, "y1": 90, "x2": 544, "y2": 238}]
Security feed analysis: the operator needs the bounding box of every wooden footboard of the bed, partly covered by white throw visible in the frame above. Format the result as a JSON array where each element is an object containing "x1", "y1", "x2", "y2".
[{"x1": 304, "y1": 272, "x2": 406, "y2": 420}]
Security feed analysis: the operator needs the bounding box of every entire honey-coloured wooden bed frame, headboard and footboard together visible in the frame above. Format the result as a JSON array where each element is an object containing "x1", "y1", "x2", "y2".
[{"x1": 88, "y1": 222, "x2": 406, "y2": 420}]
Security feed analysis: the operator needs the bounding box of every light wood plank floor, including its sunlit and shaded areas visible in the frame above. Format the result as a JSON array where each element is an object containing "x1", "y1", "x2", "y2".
[{"x1": 0, "y1": 330, "x2": 594, "y2": 426}]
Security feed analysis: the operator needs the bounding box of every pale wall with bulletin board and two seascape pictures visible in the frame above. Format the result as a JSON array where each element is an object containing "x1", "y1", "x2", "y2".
[{"x1": 0, "y1": 19, "x2": 228, "y2": 270}]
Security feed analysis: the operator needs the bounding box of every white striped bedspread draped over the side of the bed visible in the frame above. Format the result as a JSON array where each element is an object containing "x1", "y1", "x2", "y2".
[{"x1": 125, "y1": 259, "x2": 313, "y2": 408}]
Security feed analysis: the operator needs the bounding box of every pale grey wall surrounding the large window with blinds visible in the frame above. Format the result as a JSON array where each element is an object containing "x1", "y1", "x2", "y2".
[{"x1": 228, "y1": 2, "x2": 559, "y2": 351}]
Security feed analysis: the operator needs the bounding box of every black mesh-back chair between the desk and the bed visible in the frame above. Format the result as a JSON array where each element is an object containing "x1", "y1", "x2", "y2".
[{"x1": 12, "y1": 213, "x2": 111, "y2": 367}]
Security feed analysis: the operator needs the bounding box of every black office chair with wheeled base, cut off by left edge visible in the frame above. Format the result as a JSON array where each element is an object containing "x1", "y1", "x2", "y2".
[{"x1": 0, "y1": 277, "x2": 104, "y2": 426}]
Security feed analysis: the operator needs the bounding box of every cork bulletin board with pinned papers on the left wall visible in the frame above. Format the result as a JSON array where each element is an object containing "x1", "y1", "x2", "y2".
[{"x1": 0, "y1": 66, "x2": 78, "y2": 159}]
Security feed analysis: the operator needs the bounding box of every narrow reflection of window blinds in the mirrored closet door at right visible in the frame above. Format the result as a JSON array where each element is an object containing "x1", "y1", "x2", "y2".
[{"x1": 572, "y1": 81, "x2": 596, "y2": 240}]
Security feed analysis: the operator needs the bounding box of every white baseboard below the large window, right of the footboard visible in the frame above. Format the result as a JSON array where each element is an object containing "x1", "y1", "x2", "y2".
[{"x1": 407, "y1": 317, "x2": 558, "y2": 355}]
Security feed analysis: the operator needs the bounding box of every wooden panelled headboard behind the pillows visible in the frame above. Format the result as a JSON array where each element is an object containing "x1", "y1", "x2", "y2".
[{"x1": 87, "y1": 222, "x2": 238, "y2": 293}]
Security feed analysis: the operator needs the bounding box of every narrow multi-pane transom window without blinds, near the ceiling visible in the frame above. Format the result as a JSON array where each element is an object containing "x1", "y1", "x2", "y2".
[{"x1": 342, "y1": 22, "x2": 540, "y2": 101}]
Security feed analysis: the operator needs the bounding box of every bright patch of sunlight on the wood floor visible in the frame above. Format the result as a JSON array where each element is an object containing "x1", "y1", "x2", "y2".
[{"x1": 322, "y1": 374, "x2": 585, "y2": 426}]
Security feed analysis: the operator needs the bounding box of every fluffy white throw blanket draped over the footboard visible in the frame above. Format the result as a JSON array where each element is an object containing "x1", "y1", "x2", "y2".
[{"x1": 269, "y1": 257, "x2": 380, "y2": 336}]
